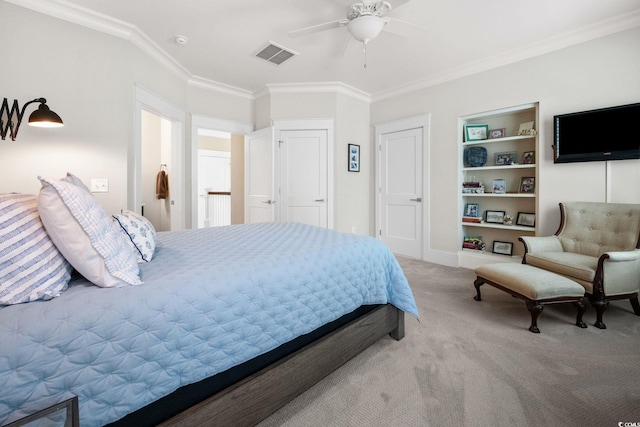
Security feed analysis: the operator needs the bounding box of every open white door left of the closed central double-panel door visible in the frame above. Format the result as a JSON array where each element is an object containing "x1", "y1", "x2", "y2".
[{"x1": 244, "y1": 128, "x2": 276, "y2": 224}]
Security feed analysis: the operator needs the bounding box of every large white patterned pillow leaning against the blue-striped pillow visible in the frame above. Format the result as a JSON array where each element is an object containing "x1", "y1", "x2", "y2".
[{"x1": 38, "y1": 177, "x2": 142, "y2": 288}]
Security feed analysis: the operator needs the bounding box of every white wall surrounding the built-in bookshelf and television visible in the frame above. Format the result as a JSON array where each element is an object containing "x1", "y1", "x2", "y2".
[{"x1": 371, "y1": 29, "x2": 640, "y2": 264}]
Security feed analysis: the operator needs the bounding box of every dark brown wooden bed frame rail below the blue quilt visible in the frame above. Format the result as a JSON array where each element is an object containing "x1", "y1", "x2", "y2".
[{"x1": 160, "y1": 304, "x2": 404, "y2": 427}]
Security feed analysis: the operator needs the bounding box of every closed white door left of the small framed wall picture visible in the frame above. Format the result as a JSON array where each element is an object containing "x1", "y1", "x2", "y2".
[{"x1": 278, "y1": 130, "x2": 328, "y2": 228}]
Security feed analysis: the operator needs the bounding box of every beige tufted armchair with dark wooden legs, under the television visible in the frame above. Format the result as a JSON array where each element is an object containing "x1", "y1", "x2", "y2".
[{"x1": 520, "y1": 202, "x2": 640, "y2": 329}]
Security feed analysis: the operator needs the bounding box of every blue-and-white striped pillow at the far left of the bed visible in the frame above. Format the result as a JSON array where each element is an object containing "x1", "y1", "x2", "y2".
[{"x1": 0, "y1": 194, "x2": 71, "y2": 305}]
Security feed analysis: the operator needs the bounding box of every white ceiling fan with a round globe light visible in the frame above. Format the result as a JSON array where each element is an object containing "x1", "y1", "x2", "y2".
[{"x1": 289, "y1": 0, "x2": 424, "y2": 68}]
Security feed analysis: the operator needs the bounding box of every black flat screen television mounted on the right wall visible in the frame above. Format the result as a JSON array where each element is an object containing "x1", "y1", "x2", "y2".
[{"x1": 553, "y1": 103, "x2": 640, "y2": 163}]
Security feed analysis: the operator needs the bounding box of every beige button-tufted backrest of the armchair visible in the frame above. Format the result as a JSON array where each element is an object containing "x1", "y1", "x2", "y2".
[{"x1": 556, "y1": 202, "x2": 640, "y2": 258}]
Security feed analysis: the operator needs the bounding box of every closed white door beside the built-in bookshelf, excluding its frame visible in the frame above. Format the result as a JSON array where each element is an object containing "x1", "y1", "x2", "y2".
[{"x1": 379, "y1": 128, "x2": 423, "y2": 258}]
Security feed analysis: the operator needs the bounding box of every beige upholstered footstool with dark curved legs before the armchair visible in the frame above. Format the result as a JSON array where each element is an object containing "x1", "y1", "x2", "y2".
[{"x1": 473, "y1": 263, "x2": 587, "y2": 333}]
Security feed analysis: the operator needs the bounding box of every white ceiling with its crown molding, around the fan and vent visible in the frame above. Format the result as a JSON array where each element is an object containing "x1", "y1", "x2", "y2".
[{"x1": 8, "y1": 0, "x2": 640, "y2": 96}]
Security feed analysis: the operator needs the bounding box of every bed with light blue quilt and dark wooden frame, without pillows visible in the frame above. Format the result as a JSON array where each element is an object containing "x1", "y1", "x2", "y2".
[{"x1": 0, "y1": 223, "x2": 418, "y2": 427}]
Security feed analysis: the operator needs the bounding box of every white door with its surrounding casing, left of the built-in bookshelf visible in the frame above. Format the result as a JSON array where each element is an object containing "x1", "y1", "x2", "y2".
[{"x1": 376, "y1": 115, "x2": 429, "y2": 259}]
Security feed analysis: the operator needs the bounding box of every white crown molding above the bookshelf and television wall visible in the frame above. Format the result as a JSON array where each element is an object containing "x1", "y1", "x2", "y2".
[{"x1": 371, "y1": 10, "x2": 640, "y2": 103}]
